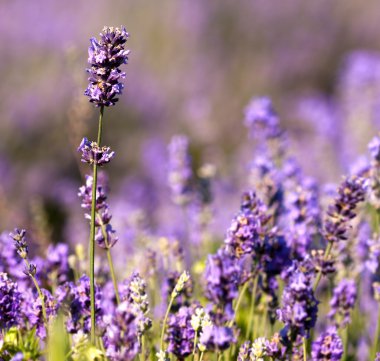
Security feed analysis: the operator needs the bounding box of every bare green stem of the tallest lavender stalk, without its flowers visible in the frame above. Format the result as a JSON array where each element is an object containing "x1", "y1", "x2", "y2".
[{"x1": 90, "y1": 106, "x2": 104, "y2": 345}]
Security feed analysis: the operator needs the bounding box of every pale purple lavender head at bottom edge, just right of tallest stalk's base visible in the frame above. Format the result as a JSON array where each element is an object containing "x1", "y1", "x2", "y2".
[{"x1": 103, "y1": 301, "x2": 140, "y2": 361}]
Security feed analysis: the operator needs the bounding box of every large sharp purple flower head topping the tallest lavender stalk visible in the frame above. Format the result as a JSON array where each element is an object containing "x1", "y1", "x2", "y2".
[{"x1": 84, "y1": 27, "x2": 130, "y2": 107}]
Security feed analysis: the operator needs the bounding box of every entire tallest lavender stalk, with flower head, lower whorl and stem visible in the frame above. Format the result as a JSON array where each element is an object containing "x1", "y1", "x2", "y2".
[{"x1": 82, "y1": 27, "x2": 129, "y2": 344}]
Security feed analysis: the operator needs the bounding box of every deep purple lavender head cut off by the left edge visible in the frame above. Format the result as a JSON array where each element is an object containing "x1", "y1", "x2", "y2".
[{"x1": 0, "y1": 273, "x2": 21, "y2": 331}]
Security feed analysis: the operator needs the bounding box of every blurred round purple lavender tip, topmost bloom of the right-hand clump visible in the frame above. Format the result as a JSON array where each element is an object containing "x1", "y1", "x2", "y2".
[{"x1": 244, "y1": 97, "x2": 280, "y2": 139}]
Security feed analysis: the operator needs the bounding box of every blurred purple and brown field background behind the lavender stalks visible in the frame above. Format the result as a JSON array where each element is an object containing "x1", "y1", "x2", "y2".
[{"x1": 0, "y1": 0, "x2": 380, "y2": 252}]
